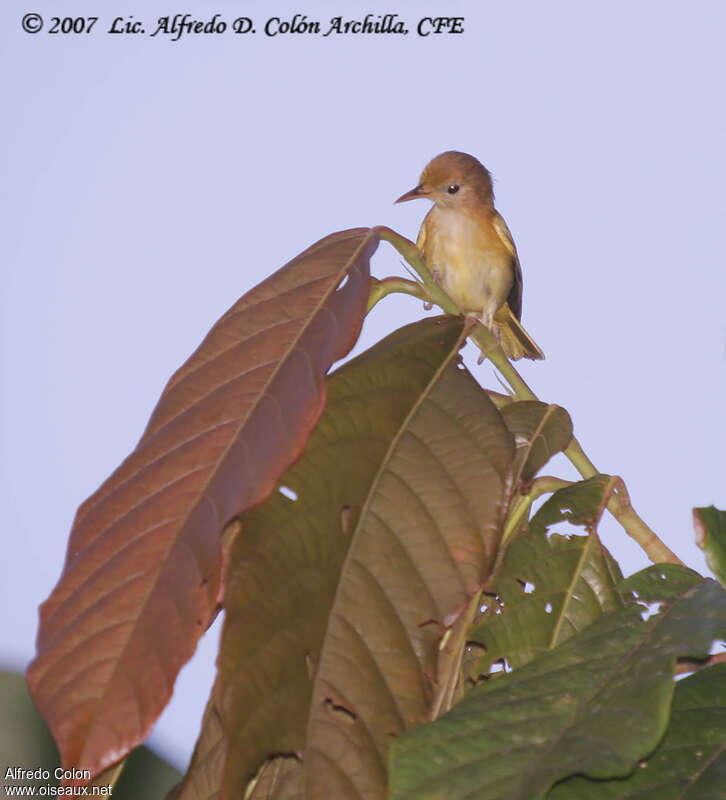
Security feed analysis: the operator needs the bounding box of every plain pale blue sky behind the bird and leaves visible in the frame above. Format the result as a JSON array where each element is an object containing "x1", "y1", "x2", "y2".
[{"x1": 0, "y1": 0, "x2": 726, "y2": 766}]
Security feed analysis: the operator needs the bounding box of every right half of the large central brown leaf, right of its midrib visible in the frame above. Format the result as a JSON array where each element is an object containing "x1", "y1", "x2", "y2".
[{"x1": 304, "y1": 336, "x2": 513, "y2": 800}]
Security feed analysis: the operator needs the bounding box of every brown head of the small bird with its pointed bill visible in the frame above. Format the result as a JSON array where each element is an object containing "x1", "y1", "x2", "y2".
[{"x1": 396, "y1": 150, "x2": 494, "y2": 208}]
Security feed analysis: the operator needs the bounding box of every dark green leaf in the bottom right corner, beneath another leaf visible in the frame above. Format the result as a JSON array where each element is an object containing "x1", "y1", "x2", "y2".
[{"x1": 547, "y1": 664, "x2": 726, "y2": 800}]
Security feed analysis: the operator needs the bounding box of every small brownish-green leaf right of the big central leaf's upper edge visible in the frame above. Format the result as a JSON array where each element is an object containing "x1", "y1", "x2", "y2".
[{"x1": 501, "y1": 400, "x2": 572, "y2": 485}]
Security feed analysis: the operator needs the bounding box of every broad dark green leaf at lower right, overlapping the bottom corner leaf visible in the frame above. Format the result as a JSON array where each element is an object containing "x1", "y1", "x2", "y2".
[{"x1": 389, "y1": 580, "x2": 726, "y2": 800}]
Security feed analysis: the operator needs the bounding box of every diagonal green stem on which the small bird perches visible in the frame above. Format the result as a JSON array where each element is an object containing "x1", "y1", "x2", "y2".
[{"x1": 376, "y1": 226, "x2": 683, "y2": 564}]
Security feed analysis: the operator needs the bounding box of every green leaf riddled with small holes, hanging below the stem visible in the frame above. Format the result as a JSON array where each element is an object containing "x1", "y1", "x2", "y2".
[{"x1": 469, "y1": 476, "x2": 622, "y2": 674}]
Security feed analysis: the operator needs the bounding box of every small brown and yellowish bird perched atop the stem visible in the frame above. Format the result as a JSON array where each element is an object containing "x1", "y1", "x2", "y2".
[{"x1": 396, "y1": 150, "x2": 544, "y2": 360}]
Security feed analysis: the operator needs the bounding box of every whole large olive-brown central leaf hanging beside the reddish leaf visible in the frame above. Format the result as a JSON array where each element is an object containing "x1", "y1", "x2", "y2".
[{"x1": 215, "y1": 317, "x2": 514, "y2": 800}]
